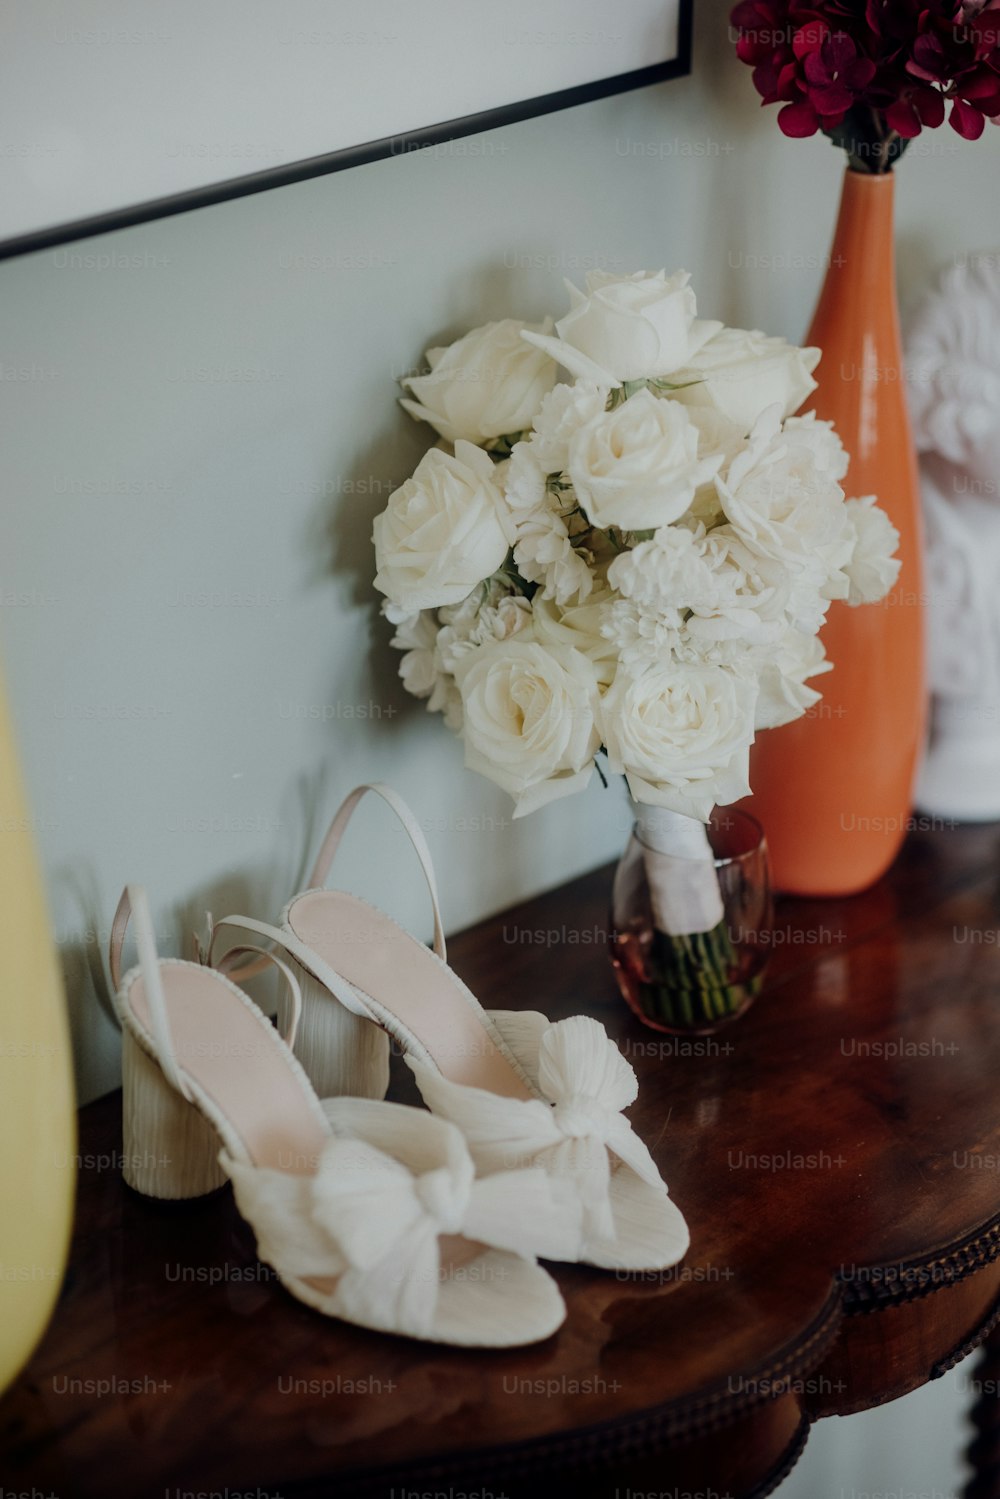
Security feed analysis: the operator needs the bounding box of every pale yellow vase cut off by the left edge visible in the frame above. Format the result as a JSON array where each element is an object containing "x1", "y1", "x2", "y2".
[{"x1": 0, "y1": 668, "x2": 76, "y2": 1390}]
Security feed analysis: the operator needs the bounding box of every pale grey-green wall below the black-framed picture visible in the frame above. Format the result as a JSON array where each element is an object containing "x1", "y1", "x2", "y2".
[{"x1": 0, "y1": 0, "x2": 1000, "y2": 1493}]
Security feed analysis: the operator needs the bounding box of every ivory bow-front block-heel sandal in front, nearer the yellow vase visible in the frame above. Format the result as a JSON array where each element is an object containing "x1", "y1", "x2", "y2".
[{"x1": 111, "y1": 886, "x2": 567, "y2": 1348}]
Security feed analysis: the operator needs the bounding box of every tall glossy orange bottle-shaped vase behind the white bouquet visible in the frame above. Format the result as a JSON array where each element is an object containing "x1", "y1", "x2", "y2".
[{"x1": 748, "y1": 169, "x2": 927, "y2": 896}]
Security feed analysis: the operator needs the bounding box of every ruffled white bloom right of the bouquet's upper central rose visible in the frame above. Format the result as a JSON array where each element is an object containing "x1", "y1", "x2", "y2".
[{"x1": 715, "y1": 412, "x2": 853, "y2": 633}]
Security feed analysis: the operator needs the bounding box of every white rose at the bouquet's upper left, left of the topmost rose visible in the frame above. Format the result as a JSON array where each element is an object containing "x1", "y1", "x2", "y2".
[{"x1": 402, "y1": 318, "x2": 556, "y2": 442}]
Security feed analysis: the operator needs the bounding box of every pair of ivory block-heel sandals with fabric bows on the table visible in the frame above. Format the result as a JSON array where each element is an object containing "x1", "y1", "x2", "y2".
[{"x1": 111, "y1": 784, "x2": 688, "y2": 1348}]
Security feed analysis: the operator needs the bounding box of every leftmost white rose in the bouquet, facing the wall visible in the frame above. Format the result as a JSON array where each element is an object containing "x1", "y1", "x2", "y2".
[{"x1": 372, "y1": 442, "x2": 514, "y2": 610}]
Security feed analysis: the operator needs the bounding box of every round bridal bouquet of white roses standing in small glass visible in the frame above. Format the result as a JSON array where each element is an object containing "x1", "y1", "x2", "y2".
[{"x1": 373, "y1": 271, "x2": 900, "y2": 929}]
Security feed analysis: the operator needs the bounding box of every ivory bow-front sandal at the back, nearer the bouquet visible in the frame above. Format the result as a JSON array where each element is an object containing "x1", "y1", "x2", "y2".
[{"x1": 212, "y1": 782, "x2": 690, "y2": 1270}]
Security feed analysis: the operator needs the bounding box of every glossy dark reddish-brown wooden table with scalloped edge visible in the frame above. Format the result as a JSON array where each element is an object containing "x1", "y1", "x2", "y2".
[{"x1": 0, "y1": 826, "x2": 1000, "y2": 1499}]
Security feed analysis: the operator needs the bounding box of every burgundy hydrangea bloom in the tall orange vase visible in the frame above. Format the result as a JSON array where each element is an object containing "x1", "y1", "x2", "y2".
[{"x1": 732, "y1": 0, "x2": 1000, "y2": 171}]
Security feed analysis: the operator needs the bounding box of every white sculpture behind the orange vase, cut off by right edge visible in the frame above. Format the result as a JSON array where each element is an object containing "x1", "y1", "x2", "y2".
[{"x1": 907, "y1": 250, "x2": 1000, "y2": 821}]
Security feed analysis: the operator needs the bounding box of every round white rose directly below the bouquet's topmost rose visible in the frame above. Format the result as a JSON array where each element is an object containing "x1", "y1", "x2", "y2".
[{"x1": 570, "y1": 390, "x2": 721, "y2": 531}]
